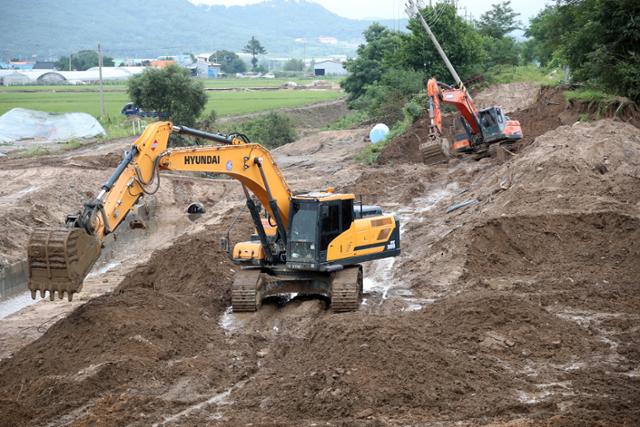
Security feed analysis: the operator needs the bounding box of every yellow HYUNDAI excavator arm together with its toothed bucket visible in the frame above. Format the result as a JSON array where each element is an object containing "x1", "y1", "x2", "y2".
[{"x1": 28, "y1": 122, "x2": 291, "y2": 300}]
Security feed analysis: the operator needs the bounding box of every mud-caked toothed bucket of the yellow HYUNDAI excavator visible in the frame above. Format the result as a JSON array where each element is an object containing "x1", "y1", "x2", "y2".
[{"x1": 28, "y1": 228, "x2": 100, "y2": 301}]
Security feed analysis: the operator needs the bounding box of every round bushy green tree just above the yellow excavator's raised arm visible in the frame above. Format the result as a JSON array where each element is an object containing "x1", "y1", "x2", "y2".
[{"x1": 127, "y1": 65, "x2": 208, "y2": 126}]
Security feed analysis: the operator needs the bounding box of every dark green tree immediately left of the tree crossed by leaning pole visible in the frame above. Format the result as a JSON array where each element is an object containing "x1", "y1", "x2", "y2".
[{"x1": 340, "y1": 23, "x2": 402, "y2": 101}]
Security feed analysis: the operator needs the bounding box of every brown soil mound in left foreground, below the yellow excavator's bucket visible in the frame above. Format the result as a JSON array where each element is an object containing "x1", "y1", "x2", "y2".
[{"x1": 0, "y1": 224, "x2": 251, "y2": 426}]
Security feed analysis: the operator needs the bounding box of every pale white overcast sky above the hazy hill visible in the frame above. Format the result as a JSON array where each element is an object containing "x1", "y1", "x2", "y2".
[{"x1": 190, "y1": 0, "x2": 548, "y2": 24}]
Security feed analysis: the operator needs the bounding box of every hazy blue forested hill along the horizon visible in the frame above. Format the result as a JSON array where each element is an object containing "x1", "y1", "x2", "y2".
[{"x1": 0, "y1": 0, "x2": 406, "y2": 58}]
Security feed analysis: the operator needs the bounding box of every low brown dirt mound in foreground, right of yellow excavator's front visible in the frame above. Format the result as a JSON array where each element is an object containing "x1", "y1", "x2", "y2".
[{"x1": 230, "y1": 293, "x2": 601, "y2": 424}]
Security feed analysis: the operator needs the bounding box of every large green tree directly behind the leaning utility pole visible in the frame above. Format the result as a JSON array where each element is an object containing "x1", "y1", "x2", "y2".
[{"x1": 396, "y1": 3, "x2": 485, "y2": 82}]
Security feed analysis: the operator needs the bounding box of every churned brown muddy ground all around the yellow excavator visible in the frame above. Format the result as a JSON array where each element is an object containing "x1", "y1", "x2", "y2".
[{"x1": 0, "y1": 83, "x2": 640, "y2": 426}]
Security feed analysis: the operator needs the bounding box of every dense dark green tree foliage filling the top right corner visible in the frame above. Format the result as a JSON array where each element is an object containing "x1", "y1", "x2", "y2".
[{"x1": 527, "y1": 0, "x2": 640, "y2": 102}]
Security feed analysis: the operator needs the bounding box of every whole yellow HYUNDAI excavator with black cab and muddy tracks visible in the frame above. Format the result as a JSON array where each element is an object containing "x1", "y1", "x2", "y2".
[{"x1": 28, "y1": 122, "x2": 400, "y2": 312}]
